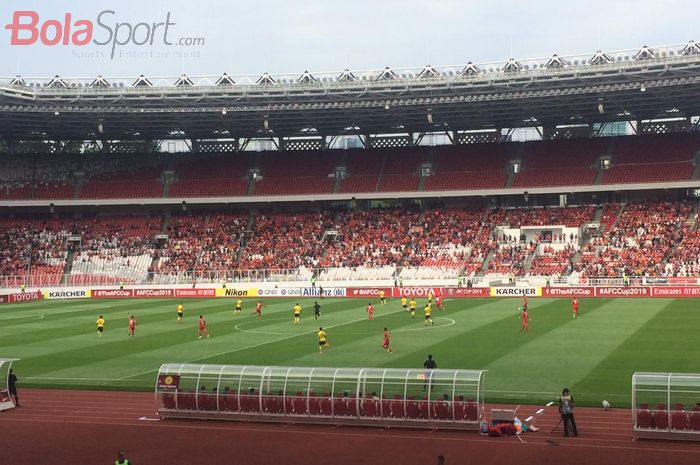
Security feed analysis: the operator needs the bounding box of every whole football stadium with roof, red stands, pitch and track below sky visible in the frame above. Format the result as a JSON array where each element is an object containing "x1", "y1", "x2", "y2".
[{"x1": 0, "y1": 2, "x2": 700, "y2": 465}]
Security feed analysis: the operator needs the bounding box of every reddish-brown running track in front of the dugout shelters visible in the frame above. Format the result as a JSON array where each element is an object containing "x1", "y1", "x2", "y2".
[{"x1": 0, "y1": 389, "x2": 700, "y2": 465}]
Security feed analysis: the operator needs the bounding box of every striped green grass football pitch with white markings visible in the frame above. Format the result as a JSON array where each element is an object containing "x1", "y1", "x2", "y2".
[{"x1": 0, "y1": 298, "x2": 700, "y2": 406}]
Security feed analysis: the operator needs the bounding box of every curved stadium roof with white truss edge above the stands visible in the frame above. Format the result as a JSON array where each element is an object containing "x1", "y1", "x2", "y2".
[{"x1": 0, "y1": 41, "x2": 700, "y2": 140}]
